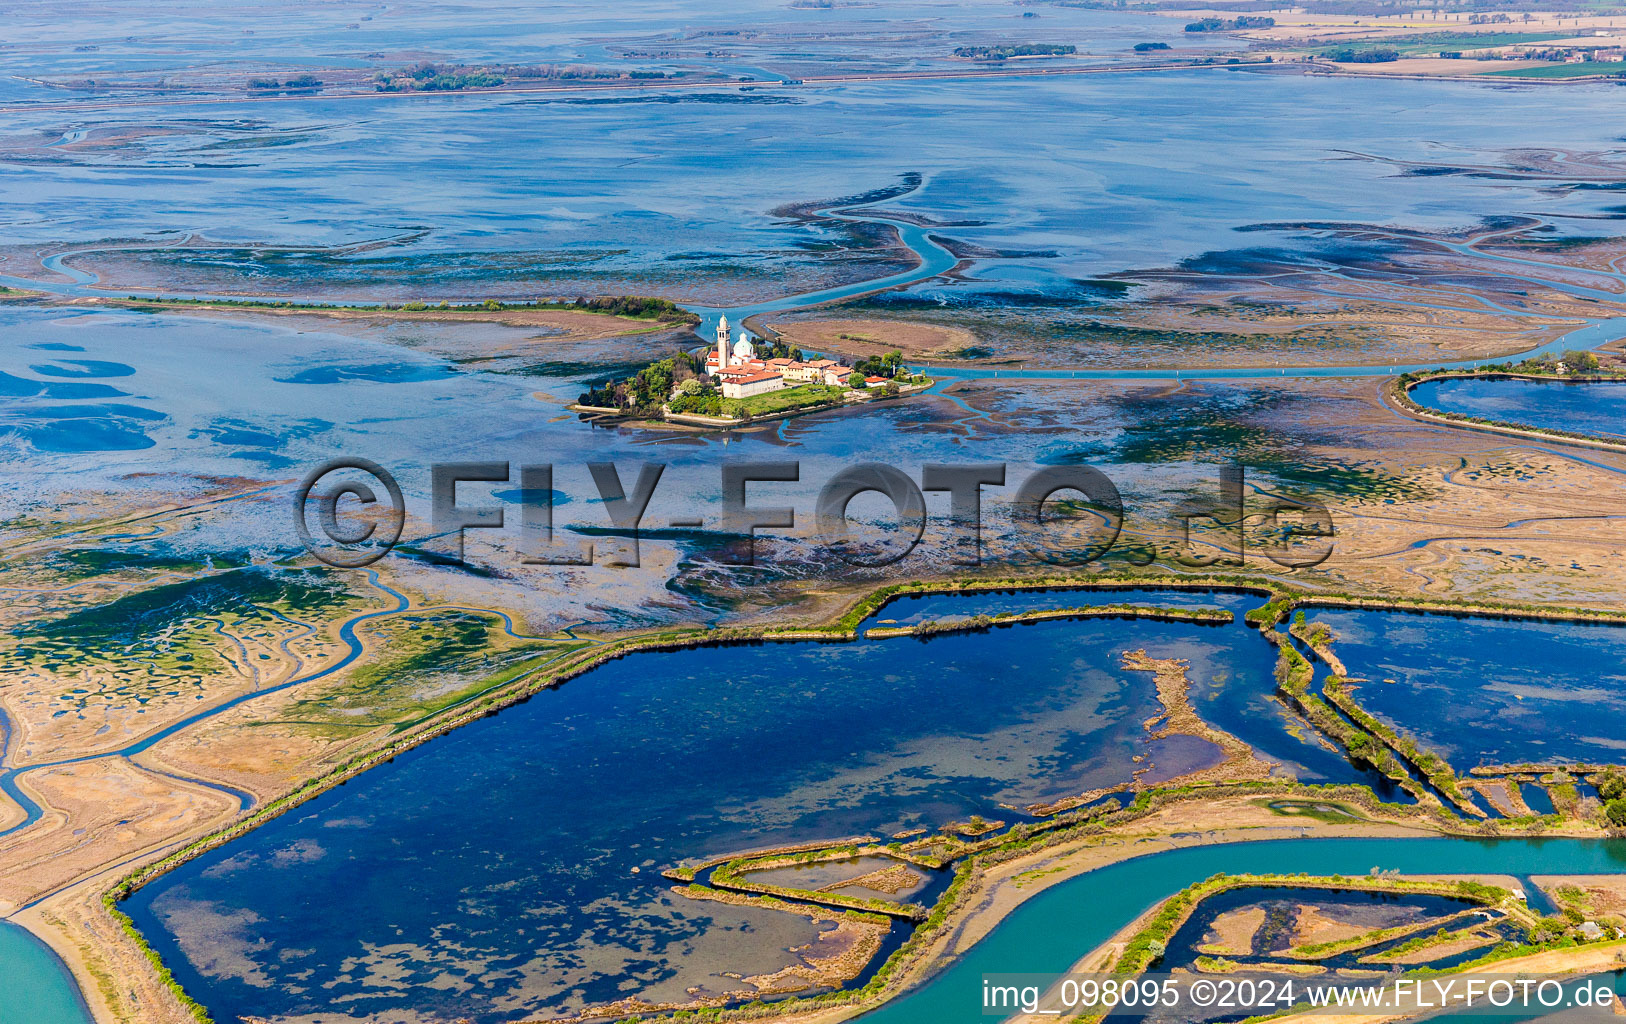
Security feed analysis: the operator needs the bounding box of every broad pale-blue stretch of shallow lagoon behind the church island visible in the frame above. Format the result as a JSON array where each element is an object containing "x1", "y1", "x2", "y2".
[{"x1": 0, "y1": 57, "x2": 1616, "y2": 304}]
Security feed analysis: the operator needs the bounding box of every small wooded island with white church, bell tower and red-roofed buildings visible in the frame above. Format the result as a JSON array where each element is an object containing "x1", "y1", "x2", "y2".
[{"x1": 571, "y1": 315, "x2": 932, "y2": 427}]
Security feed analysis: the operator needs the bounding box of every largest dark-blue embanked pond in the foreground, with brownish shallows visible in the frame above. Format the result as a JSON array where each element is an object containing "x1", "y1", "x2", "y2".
[{"x1": 127, "y1": 595, "x2": 1309, "y2": 1022}]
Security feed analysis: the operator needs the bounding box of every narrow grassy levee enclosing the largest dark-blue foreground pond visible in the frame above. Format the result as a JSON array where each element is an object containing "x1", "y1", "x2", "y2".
[{"x1": 102, "y1": 572, "x2": 1626, "y2": 1024}]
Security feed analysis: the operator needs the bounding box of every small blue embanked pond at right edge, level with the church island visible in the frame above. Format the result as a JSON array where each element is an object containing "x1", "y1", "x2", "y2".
[{"x1": 1411, "y1": 379, "x2": 1626, "y2": 437}]
